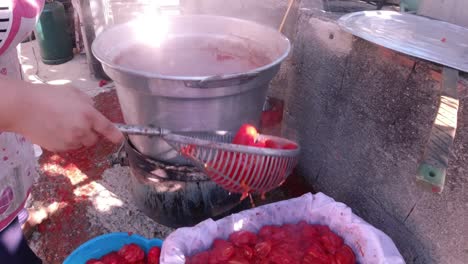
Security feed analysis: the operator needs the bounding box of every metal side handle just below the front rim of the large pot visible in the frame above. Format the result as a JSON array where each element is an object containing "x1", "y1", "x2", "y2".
[{"x1": 185, "y1": 72, "x2": 260, "y2": 89}]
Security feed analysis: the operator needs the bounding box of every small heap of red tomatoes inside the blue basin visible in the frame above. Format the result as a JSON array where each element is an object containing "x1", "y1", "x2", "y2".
[{"x1": 86, "y1": 244, "x2": 161, "y2": 264}]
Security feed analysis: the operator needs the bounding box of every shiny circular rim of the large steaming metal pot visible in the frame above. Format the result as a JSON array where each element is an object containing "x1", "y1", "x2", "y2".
[{"x1": 91, "y1": 15, "x2": 291, "y2": 81}]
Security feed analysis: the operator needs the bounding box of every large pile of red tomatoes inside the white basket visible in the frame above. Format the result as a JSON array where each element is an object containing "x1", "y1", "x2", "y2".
[{"x1": 186, "y1": 222, "x2": 356, "y2": 264}]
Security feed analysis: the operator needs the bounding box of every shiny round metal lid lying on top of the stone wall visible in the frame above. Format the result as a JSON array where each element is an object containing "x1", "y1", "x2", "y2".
[{"x1": 338, "y1": 11, "x2": 468, "y2": 72}]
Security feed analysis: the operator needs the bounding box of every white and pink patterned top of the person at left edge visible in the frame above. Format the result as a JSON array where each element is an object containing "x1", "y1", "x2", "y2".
[{"x1": 0, "y1": 0, "x2": 44, "y2": 230}]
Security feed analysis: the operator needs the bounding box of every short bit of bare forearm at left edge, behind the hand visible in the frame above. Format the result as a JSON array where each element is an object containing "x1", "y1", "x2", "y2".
[{"x1": 0, "y1": 80, "x2": 31, "y2": 132}]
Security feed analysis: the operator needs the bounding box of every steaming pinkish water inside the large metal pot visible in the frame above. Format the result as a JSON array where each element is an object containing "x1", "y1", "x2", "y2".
[{"x1": 114, "y1": 35, "x2": 273, "y2": 77}]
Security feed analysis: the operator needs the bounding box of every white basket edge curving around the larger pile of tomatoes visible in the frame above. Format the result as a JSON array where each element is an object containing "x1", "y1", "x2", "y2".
[{"x1": 161, "y1": 193, "x2": 405, "y2": 264}]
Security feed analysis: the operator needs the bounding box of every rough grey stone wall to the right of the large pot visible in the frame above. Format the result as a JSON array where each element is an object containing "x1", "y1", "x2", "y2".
[{"x1": 283, "y1": 6, "x2": 468, "y2": 264}]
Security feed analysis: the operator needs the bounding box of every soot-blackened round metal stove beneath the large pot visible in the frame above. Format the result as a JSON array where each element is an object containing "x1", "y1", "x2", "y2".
[{"x1": 111, "y1": 139, "x2": 250, "y2": 228}]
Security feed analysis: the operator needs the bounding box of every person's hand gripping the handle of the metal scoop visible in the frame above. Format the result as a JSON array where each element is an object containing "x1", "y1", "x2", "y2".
[{"x1": 13, "y1": 81, "x2": 123, "y2": 151}]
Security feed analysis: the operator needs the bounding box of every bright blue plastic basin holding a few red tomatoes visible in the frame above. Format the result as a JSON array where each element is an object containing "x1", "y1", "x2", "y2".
[{"x1": 63, "y1": 233, "x2": 163, "y2": 264}]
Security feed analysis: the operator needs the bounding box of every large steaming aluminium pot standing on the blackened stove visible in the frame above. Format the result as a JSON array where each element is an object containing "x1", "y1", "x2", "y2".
[{"x1": 92, "y1": 15, "x2": 290, "y2": 164}]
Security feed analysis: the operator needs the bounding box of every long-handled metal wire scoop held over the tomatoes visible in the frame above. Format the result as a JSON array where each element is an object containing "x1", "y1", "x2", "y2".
[{"x1": 116, "y1": 124, "x2": 300, "y2": 193}]
